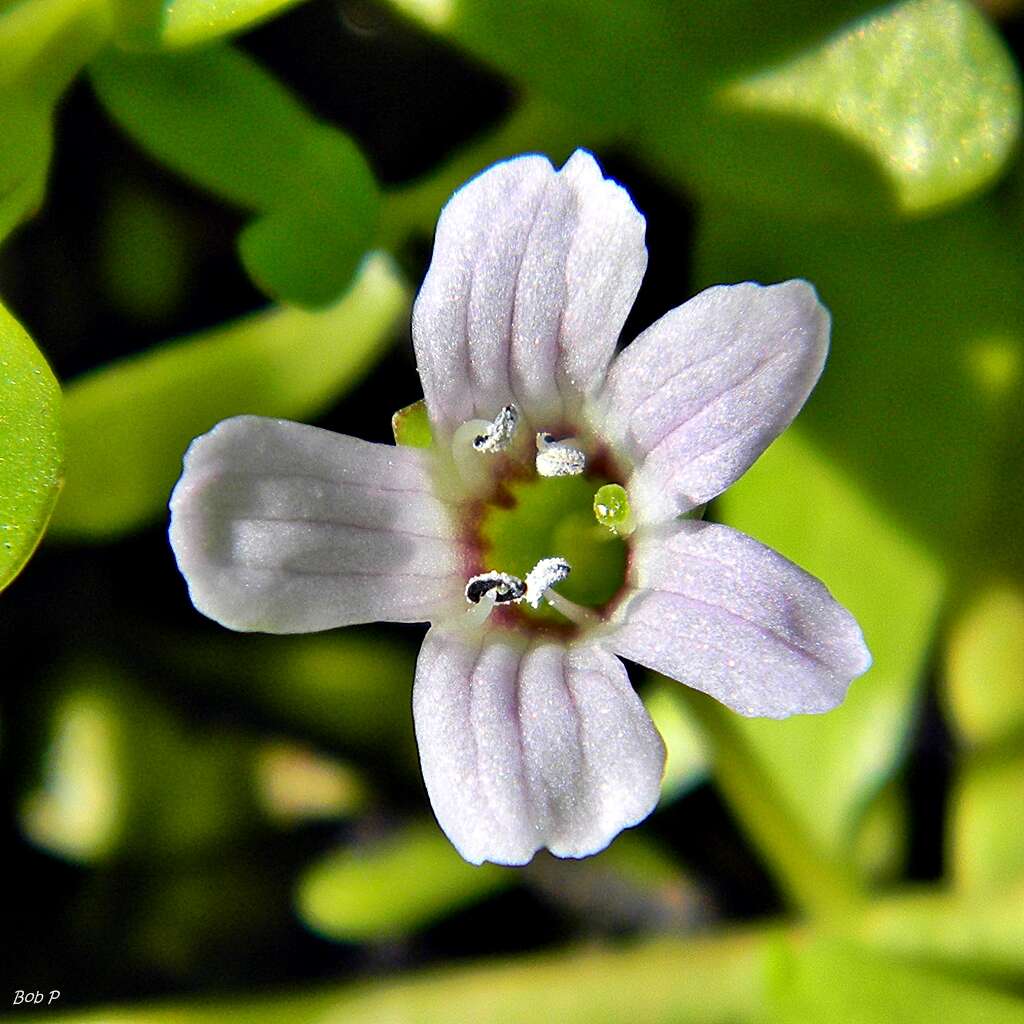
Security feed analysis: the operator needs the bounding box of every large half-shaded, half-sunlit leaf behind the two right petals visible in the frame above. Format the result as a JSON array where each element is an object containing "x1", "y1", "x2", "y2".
[{"x1": 696, "y1": 188, "x2": 1024, "y2": 868}]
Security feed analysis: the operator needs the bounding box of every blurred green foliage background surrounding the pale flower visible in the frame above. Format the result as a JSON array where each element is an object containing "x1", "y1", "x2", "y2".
[{"x1": 0, "y1": 0, "x2": 1024, "y2": 1024}]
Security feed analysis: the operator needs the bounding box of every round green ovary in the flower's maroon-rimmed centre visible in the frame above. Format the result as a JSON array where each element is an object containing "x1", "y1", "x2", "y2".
[{"x1": 480, "y1": 476, "x2": 627, "y2": 620}]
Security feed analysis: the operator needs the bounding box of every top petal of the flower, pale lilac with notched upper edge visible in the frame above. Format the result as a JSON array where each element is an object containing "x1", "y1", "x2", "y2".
[{"x1": 413, "y1": 150, "x2": 647, "y2": 432}]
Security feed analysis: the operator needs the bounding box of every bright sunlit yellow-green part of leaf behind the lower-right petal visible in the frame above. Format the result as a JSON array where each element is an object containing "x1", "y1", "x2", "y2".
[{"x1": 718, "y1": 428, "x2": 942, "y2": 857}]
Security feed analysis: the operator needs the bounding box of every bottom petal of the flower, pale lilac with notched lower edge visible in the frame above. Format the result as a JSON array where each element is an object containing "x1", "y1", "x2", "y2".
[{"x1": 413, "y1": 629, "x2": 665, "y2": 864}]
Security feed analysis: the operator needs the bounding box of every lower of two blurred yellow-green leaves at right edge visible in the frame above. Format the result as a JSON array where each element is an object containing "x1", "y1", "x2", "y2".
[{"x1": 946, "y1": 749, "x2": 1024, "y2": 899}]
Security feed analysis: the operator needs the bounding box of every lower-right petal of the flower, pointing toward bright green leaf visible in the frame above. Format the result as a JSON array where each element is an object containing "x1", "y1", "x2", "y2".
[{"x1": 607, "y1": 520, "x2": 871, "y2": 718}]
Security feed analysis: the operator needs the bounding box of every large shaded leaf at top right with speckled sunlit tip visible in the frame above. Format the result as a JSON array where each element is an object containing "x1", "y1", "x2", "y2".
[{"x1": 392, "y1": 0, "x2": 1020, "y2": 216}]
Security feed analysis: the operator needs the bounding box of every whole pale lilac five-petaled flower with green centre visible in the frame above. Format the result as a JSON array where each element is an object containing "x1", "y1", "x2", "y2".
[{"x1": 170, "y1": 152, "x2": 870, "y2": 864}]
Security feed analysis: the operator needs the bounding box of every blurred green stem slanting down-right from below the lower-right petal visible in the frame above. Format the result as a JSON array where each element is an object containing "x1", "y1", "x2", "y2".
[{"x1": 678, "y1": 686, "x2": 863, "y2": 921}]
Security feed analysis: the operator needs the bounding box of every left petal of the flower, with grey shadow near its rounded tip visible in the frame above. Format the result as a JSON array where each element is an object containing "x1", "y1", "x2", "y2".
[{"x1": 170, "y1": 416, "x2": 465, "y2": 633}]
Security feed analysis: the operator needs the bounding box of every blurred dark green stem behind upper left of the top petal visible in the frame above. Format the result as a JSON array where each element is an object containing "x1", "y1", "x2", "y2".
[{"x1": 376, "y1": 96, "x2": 606, "y2": 252}]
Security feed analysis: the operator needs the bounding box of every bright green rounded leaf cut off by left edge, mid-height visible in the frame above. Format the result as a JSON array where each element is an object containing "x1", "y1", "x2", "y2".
[{"x1": 0, "y1": 305, "x2": 65, "y2": 590}]
